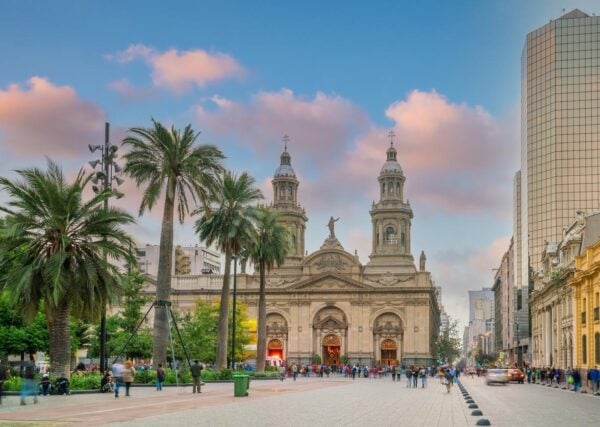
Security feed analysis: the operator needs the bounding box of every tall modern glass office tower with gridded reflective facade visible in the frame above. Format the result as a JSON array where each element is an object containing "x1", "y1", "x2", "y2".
[{"x1": 514, "y1": 9, "x2": 600, "y2": 366}]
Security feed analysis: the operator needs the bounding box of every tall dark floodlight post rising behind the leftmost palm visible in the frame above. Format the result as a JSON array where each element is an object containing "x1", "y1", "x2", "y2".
[{"x1": 88, "y1": 122, "x2": 123, "y2": 372}]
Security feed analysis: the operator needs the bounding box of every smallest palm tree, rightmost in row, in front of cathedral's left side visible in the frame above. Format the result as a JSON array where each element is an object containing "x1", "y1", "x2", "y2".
[{"x1": 250, "y1": 208, "x2": 289, "y2": 372}]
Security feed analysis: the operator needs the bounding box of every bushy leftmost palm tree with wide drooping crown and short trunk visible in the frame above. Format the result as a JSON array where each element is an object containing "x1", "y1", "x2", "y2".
[{"x1": 0, "y1": 160, "x2": 134, "y2": 375}]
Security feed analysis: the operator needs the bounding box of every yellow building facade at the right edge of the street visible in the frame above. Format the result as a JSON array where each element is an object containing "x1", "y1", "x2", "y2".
[{"x1": 570, "y1": 240, "x2": 600, "y2": 372}]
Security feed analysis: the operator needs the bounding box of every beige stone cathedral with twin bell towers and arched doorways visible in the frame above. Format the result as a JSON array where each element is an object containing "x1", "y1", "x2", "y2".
[{"x1": 146, "y1": 144, "x2": 440, "y2": 365}]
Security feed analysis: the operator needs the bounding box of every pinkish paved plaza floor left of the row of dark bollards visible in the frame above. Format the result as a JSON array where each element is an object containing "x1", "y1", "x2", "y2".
[{"x1": 0, "y1": 377, "x2": 478, "y2": 427}]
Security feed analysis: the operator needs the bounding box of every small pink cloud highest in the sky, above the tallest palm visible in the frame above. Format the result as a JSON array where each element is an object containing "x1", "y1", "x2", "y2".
[{"x1": 105, "y1": 44, "x2": 244, "y2": 93}]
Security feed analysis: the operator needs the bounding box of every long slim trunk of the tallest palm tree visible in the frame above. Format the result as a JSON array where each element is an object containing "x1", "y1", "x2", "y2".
[{"x1": 152, "y1": 177, "x2": 175, "y2": 369}]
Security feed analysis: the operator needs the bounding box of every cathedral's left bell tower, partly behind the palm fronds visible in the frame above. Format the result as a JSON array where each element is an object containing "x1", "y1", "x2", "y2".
[{"x1": 271, "y1": 135, "x2": 308, "y2": 264}]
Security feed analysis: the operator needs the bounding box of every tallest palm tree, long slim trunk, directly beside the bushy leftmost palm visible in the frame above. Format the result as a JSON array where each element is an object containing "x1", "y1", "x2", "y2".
[{"x1": 123, "y1": 120, "x2": 225, "y2": 367}]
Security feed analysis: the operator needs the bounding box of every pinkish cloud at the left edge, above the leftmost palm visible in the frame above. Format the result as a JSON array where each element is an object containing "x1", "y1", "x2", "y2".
[{"x1": 0, "y1": 77, "x2": 104, "y2": 158}]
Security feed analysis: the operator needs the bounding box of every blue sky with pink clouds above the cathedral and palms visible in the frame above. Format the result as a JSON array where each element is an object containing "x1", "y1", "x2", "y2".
[{"x1": 0, "y1": 0, "x2": 600, "y2": 328}]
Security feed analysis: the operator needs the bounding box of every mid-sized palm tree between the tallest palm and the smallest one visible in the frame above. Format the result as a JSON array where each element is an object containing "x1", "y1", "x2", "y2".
[{"x1": 196, "y1": 172, "x2": 262, "y2": 369}]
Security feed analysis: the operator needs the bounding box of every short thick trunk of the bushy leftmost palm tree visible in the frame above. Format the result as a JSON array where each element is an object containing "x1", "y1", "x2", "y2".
[{"x1": 48, "y1": 301, "x2": 71, "y2": 376}]
